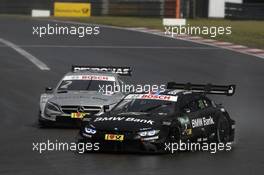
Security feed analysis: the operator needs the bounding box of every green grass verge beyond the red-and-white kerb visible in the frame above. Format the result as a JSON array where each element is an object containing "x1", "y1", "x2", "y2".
[{"x1": 55, "y1": 17, "x2": 264, "y2": 49}]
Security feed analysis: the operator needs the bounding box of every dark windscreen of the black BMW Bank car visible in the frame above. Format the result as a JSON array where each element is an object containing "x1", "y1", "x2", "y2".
[{"x1": 111, "y1": 99, "x2": 175, "y2": 115}]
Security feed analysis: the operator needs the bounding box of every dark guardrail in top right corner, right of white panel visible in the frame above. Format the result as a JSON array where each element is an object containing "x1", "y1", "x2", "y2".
[{"x1": 225, "y1": 3, "x2": 264, "y2": 20}]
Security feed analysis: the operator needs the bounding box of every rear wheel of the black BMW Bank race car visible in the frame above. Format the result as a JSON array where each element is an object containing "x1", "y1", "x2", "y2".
[{"x1": 215, "y1": 115, "x2": 231, "y2": 143}]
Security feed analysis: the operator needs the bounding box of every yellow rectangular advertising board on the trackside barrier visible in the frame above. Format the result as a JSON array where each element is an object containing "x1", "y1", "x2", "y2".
[{"x1": 54, "y1": 2, "x2": 91, "y2": 17}]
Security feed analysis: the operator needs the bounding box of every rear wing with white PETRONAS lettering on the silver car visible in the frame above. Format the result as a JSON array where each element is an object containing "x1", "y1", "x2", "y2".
[{"x1": 72, "y1": 65, "x2": 132, "y2": 76}]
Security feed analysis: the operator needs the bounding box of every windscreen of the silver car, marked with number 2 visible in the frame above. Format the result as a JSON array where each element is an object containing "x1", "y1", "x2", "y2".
[{"x1": 57, "y1": 80, "x2": 114, "y2": 91}]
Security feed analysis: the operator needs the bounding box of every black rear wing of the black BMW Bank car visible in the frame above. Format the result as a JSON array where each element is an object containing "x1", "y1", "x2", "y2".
[{"x1": 167, "y1": 82, "x2": 236, "y2": 96}]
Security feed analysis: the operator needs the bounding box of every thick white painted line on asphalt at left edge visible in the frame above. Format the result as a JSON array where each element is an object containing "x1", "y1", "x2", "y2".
[{"x1": 0, "y1": 38, "x2": 50, "y2": 70}]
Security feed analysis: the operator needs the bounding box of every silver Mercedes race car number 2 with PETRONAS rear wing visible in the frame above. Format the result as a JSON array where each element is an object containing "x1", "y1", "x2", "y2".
[{"x1": 39, "y1": 66, "x2": 131, "y2": 126}]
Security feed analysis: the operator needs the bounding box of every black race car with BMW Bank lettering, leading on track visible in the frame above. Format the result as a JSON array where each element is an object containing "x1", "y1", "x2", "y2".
[{"x1": 78, "y1": 82, "x2": 235, "y2": 152}]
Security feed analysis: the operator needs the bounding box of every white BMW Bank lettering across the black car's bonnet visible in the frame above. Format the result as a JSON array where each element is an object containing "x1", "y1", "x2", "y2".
[{"x1": 94, "y1": 117, "x2": 154, "y2": 125}]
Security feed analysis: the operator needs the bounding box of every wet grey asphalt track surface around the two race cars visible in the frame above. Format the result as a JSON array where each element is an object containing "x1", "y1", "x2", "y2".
[{"x1": 0, "y1": 17, "x2": 264, "y2": 175}]
